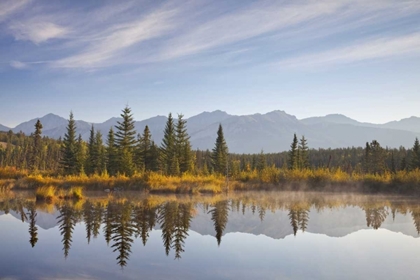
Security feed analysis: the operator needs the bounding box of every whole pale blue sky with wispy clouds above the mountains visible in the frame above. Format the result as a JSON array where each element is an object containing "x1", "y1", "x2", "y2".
[{"x1": 0, "y1": 0, "x2": 420, "y2": 127}]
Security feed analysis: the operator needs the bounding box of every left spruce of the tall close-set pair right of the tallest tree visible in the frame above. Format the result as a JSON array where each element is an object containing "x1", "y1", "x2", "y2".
[{"x1": 160, "y1": 113, "x2": 176, "y2": 175}]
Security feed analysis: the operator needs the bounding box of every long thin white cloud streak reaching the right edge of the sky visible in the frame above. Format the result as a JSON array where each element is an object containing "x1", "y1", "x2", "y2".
[{"x1": 277, "y1": 33, "x2": 420, "y2": 67}]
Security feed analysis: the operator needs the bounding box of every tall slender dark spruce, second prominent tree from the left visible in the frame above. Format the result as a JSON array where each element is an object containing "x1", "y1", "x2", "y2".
[{"x1": 60, "y1": 112, "x2": 78, "y2": 175}]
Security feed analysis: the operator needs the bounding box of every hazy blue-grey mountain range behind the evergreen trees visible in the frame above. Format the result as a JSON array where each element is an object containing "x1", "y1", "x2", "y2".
[{"x1": 0, "y1": 110, "x2": 420, "y2": 153}]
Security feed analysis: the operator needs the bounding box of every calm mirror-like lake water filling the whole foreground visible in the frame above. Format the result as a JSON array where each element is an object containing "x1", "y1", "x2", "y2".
[{"x1": 0, "y1": 192, "x2": 420, "y2": 279}]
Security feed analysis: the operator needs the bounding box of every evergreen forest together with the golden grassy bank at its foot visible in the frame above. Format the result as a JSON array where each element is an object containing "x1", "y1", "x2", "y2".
[{"x1": 0, "y1": 106, "x2": 420, "y2": 193}]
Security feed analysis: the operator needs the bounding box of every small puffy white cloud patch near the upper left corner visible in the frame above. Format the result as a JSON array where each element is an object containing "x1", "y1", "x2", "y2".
[{"x1": 9, "y1": 19, "x2": 69, "y2": 44}]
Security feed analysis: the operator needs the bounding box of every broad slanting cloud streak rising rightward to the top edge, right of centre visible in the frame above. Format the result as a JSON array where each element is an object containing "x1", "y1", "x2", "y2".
[{"x1": 153, "y1": 1, "x2": 341, "y2": 60}]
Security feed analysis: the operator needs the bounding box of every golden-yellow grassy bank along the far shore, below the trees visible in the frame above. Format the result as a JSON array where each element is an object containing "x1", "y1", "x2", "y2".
[{"x1": 0, "y1": 168, "x2": 420, "y2": 194}]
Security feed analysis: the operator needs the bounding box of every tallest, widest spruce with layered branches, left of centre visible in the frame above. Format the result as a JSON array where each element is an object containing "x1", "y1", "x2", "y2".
[{"x1": 115, "y1": 106, "x2": 136, "y2": 176}]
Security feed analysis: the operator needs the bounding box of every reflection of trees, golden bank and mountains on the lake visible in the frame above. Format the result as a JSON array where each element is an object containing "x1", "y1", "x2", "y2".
[{"x1": 0, "y1": 192, "x2": 420, "y2": 268}]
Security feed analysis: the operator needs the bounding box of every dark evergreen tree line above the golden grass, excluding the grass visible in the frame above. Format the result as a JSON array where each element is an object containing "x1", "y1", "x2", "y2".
[{"x1": 0, "y1": 106, "x2": 420, "y2": 176}]
